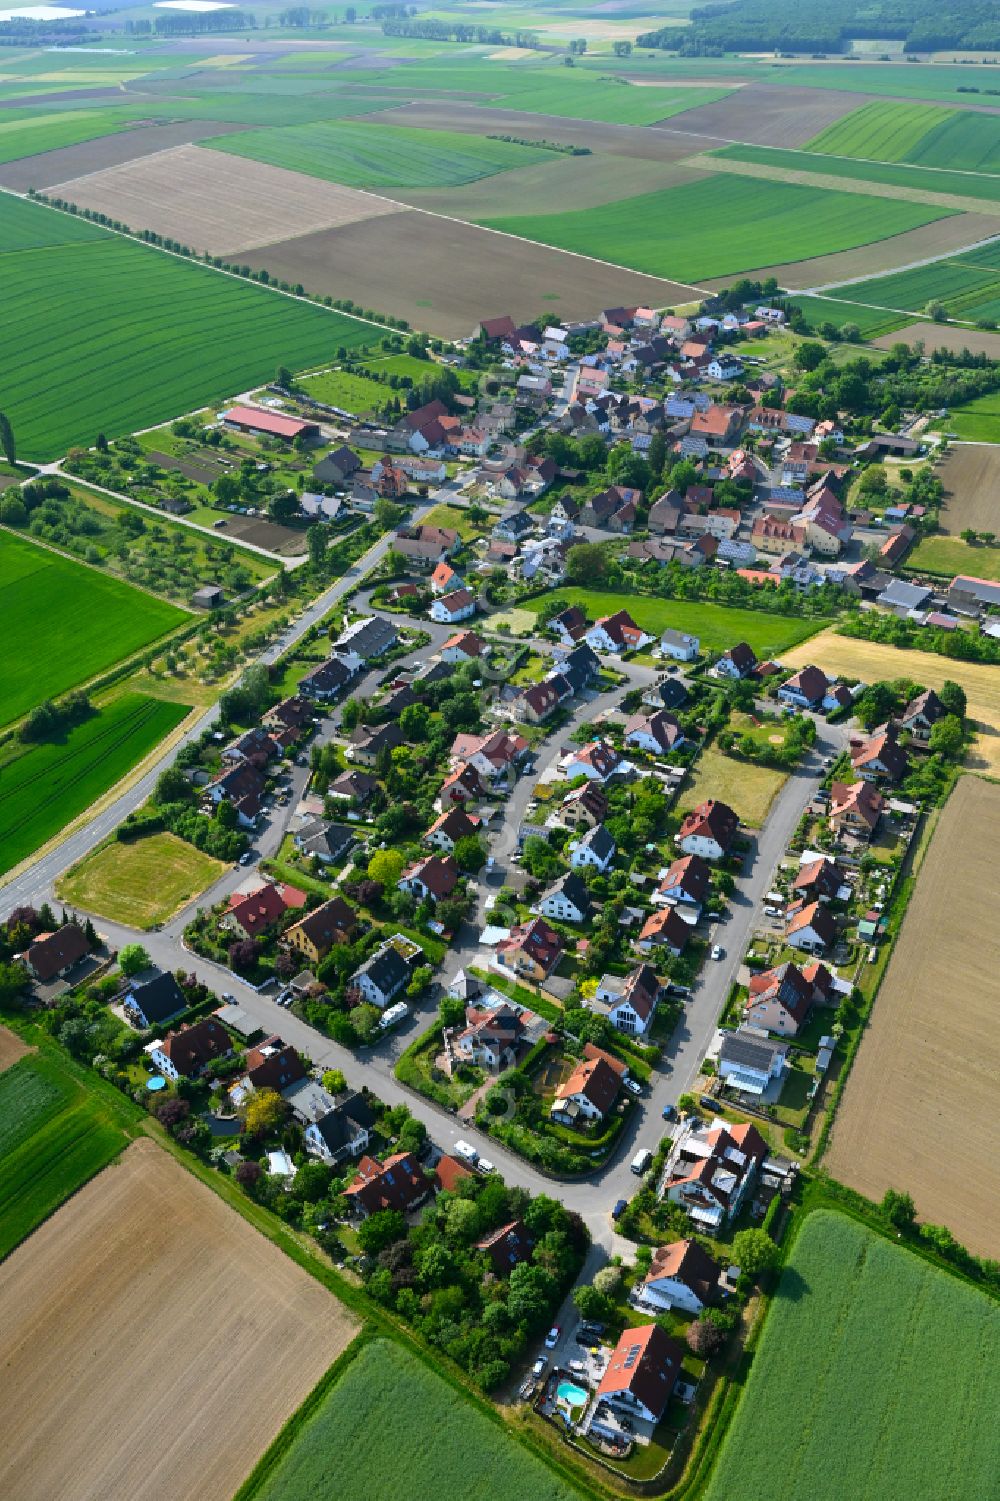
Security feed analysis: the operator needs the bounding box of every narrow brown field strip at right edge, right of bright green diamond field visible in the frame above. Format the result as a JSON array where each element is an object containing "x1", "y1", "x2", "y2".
[{"x1": 706, "y1": 213, "x2": 997, "y2": 297}]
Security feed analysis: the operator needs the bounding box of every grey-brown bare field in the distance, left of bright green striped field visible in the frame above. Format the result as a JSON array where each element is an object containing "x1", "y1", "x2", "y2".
[{"x1": 651, "y1": 84, "x2": 857, "y2": 146}]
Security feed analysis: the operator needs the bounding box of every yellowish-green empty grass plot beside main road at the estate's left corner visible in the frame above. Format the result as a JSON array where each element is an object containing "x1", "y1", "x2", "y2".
[{"x1": 59, "y1": 833, "x2": 225, "y2": 928}]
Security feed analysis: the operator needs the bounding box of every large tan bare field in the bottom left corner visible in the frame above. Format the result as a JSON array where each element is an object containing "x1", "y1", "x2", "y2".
[{"x1": 0, "y1": 1141, "x2": 354, "y2": 1501}]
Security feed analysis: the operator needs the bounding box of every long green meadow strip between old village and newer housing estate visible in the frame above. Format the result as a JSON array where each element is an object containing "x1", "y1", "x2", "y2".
[{"x1": 524, "y1": 588, "x2": 824, "y2": 659}]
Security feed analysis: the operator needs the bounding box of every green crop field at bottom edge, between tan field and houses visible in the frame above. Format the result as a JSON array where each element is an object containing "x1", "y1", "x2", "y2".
[{"x1": 240, "y1": 1339, "x2": 580, "y2": 1501}]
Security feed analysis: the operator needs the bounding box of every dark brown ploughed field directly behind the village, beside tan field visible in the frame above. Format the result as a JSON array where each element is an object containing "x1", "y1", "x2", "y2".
[{"x1": 243, "y1": 209, "x2": 695, "y2": 338}]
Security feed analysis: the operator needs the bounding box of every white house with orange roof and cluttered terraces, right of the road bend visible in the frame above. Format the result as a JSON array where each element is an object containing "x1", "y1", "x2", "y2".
[{"x1": 661, "y1": 1124, "x2": 767, "y2": 1232}]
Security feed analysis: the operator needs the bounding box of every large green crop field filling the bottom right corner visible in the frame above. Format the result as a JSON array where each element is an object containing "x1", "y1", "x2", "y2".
[{"x1": 704, "y1": 1210, "x2": 1000, "y2": 1501}]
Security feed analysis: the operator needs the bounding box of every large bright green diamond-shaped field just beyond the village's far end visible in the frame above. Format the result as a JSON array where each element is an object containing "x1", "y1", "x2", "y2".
[{"x1": 482, "y1": 177, "x2": 944, "y2": 285}]
